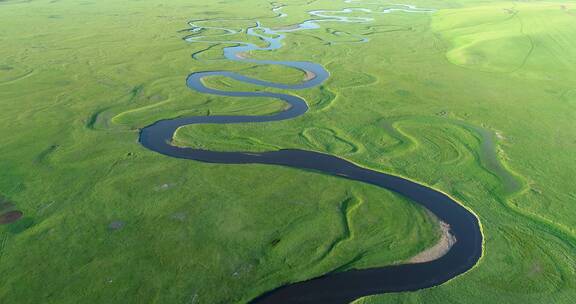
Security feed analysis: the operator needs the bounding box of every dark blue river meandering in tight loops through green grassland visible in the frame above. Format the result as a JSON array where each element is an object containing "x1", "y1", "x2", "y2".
[{"x1": 140, "y1": 1, "x2": 482, "y2": 304}]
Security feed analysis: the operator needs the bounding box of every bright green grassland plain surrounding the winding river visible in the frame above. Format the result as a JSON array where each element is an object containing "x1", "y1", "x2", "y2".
[{"x1": 0, "y1": 0, "x2": 576, "y2": 303}]
